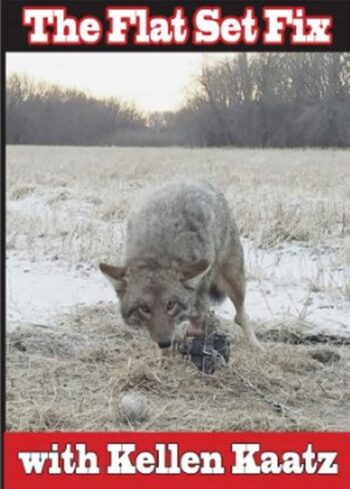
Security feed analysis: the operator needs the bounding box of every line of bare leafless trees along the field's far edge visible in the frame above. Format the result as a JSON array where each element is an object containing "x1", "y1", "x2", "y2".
[{"x1": 6, "y1": 53, "x2": 350, "y2": 147}]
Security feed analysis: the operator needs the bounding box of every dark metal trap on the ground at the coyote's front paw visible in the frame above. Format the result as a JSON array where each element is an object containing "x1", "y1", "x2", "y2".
[{"x1": 175, "y1": 314, "x2": 230, "y2": 374}]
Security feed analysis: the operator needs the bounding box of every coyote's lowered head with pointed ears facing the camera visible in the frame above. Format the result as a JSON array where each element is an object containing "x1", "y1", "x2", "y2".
[{"x1": 99, "y1": 261, "x2": 208, "y2": 348}]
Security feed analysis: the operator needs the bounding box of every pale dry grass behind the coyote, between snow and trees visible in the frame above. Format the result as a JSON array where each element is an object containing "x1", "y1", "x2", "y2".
[{"x1": 7, "y1": 146, "x2": 350, "y2": 263}]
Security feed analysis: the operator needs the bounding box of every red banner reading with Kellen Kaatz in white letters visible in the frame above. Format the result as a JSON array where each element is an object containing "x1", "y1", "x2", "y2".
[{"x1": 4, "y1": 433, "x2": 350, "y2": 489}]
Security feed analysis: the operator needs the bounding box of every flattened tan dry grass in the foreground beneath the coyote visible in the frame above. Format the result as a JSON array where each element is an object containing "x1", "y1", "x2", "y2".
[{"x1": 7, "y1": 306, "x2": 350, "y2": 431}]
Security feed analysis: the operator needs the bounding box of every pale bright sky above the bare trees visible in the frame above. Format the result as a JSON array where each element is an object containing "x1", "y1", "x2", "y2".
[{"x1": 6, "y1": 53, "x2": 230, "y2": 111}]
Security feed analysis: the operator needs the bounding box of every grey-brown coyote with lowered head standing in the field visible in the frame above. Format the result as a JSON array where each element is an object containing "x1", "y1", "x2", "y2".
[{"x1": 99, "y1": 182, "x2": 259, "y2": 348}]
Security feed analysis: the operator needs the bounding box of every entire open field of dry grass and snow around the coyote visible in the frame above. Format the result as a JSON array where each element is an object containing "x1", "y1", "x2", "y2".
[{"x1": 7, "y1": 146, "x2": 350, "y2": 431}]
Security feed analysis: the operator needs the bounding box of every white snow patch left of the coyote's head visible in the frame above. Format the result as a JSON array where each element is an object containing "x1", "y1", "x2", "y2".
[{"x1": 6, "y1": 252, "x2": 115, "y2": 329}]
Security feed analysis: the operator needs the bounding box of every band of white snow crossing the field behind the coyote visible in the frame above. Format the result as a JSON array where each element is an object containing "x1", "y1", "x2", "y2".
[{"x1": 7, "y1": 240, "x2": 350, "y2": 335}]
